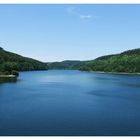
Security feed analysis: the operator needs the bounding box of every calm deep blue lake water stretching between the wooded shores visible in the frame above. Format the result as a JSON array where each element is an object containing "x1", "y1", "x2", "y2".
[{"x1": 0, "y1": 70, "x2": 140, "y2": 136}]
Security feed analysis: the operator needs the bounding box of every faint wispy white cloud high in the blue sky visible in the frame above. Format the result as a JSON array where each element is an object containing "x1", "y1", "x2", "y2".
[{"x1": 67, "y1": 7, "x2": 94, "y2": 20}]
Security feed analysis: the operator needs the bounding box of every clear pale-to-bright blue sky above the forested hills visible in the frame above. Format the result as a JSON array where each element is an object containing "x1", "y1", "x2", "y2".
[{"x1": 0, "y1": 4, "x2": 140, "y2": 62}]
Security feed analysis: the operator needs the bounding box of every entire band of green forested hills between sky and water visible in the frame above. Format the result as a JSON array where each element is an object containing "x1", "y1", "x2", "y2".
[{"x1": 0, "y1": 47, "x2": 140, "y2": 75}]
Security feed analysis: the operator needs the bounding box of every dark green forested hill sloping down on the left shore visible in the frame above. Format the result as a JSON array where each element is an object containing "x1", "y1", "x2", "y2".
[{"x1": 0, "y1": 47, "x2": 48, "y2": 73}]
